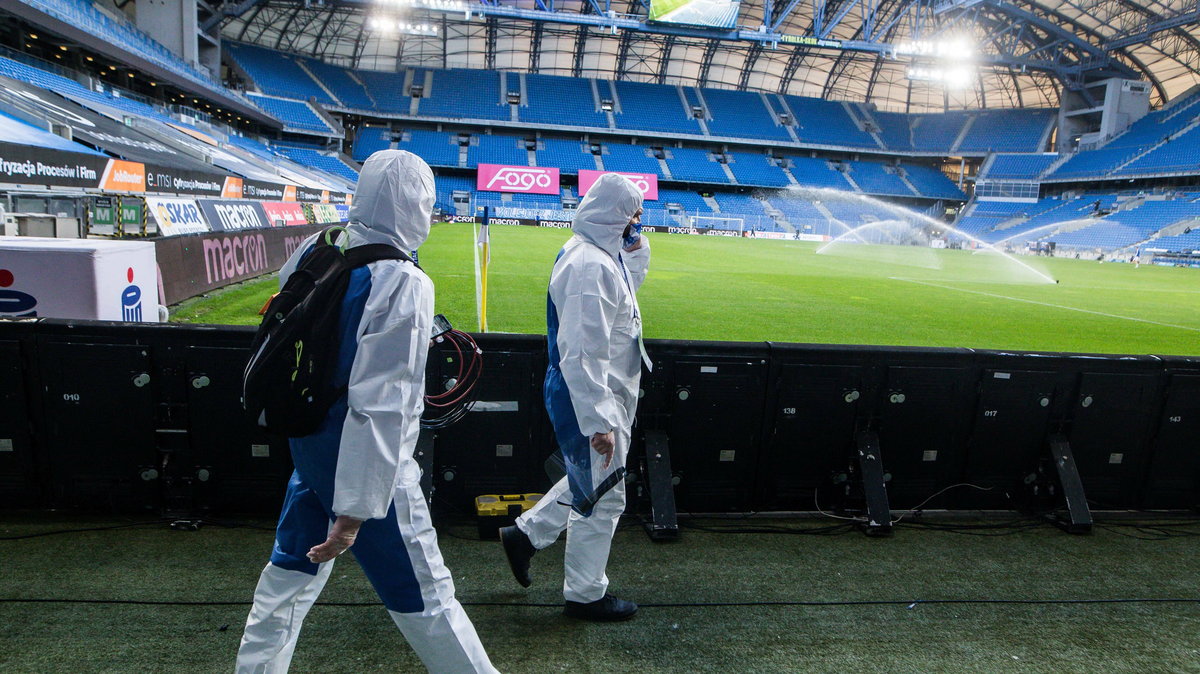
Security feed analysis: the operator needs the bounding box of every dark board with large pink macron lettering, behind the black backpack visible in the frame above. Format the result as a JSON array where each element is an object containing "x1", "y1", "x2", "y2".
[{"x1": 154, "y1": 227, "x2": 320, "y2": 305}]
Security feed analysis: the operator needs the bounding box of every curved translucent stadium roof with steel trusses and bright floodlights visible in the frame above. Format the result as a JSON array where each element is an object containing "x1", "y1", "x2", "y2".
[{"x1": 223, "y1": 0, "x2": 1200, "y2": 112}]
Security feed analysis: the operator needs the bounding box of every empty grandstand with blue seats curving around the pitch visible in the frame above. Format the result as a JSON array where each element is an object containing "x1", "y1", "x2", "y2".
[{"x1": 7, "y1": 0, "x2": 1200, "y2": 263}]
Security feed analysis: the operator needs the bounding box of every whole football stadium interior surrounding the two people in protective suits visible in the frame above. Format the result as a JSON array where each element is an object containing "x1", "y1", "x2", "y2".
[{"x1": 0, "y1": 0, "x2": 1200, "y2": 672}]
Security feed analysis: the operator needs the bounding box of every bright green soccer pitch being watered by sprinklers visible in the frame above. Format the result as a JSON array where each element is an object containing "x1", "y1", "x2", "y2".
[{"x1": 173, "y1": 224, "x2": 1200, "y2": 355}]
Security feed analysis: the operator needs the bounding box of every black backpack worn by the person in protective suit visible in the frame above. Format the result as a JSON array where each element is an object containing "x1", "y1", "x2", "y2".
[{"x1": 241, "y1": 227, "x2": 415, "y2": 438}]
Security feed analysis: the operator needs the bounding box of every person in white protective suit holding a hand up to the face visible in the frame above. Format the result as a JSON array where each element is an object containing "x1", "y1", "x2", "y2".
[{"x1": 500, "y1": 174, "x2": 650, "y2": 620}]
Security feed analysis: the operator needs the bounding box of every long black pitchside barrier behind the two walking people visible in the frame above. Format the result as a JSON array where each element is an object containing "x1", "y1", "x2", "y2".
[{"x1": 0, "y1": 319, "x2": 1200, "y2": 536}]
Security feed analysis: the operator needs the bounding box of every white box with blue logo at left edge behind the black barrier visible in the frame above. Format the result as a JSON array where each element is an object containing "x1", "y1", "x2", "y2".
[{"x1": 0, "y1": 236, "x2": 158, "y2": 323}]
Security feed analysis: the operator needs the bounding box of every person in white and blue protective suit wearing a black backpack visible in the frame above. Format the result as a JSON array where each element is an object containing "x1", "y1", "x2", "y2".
[{"x1": 236, "y1": 150, "x2": 496, "y2": 673}]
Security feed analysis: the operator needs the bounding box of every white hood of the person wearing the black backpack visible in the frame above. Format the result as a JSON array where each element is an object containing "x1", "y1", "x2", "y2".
[{"x1": 350, "y1": 150, "x2": 434, "y2": 253}]
